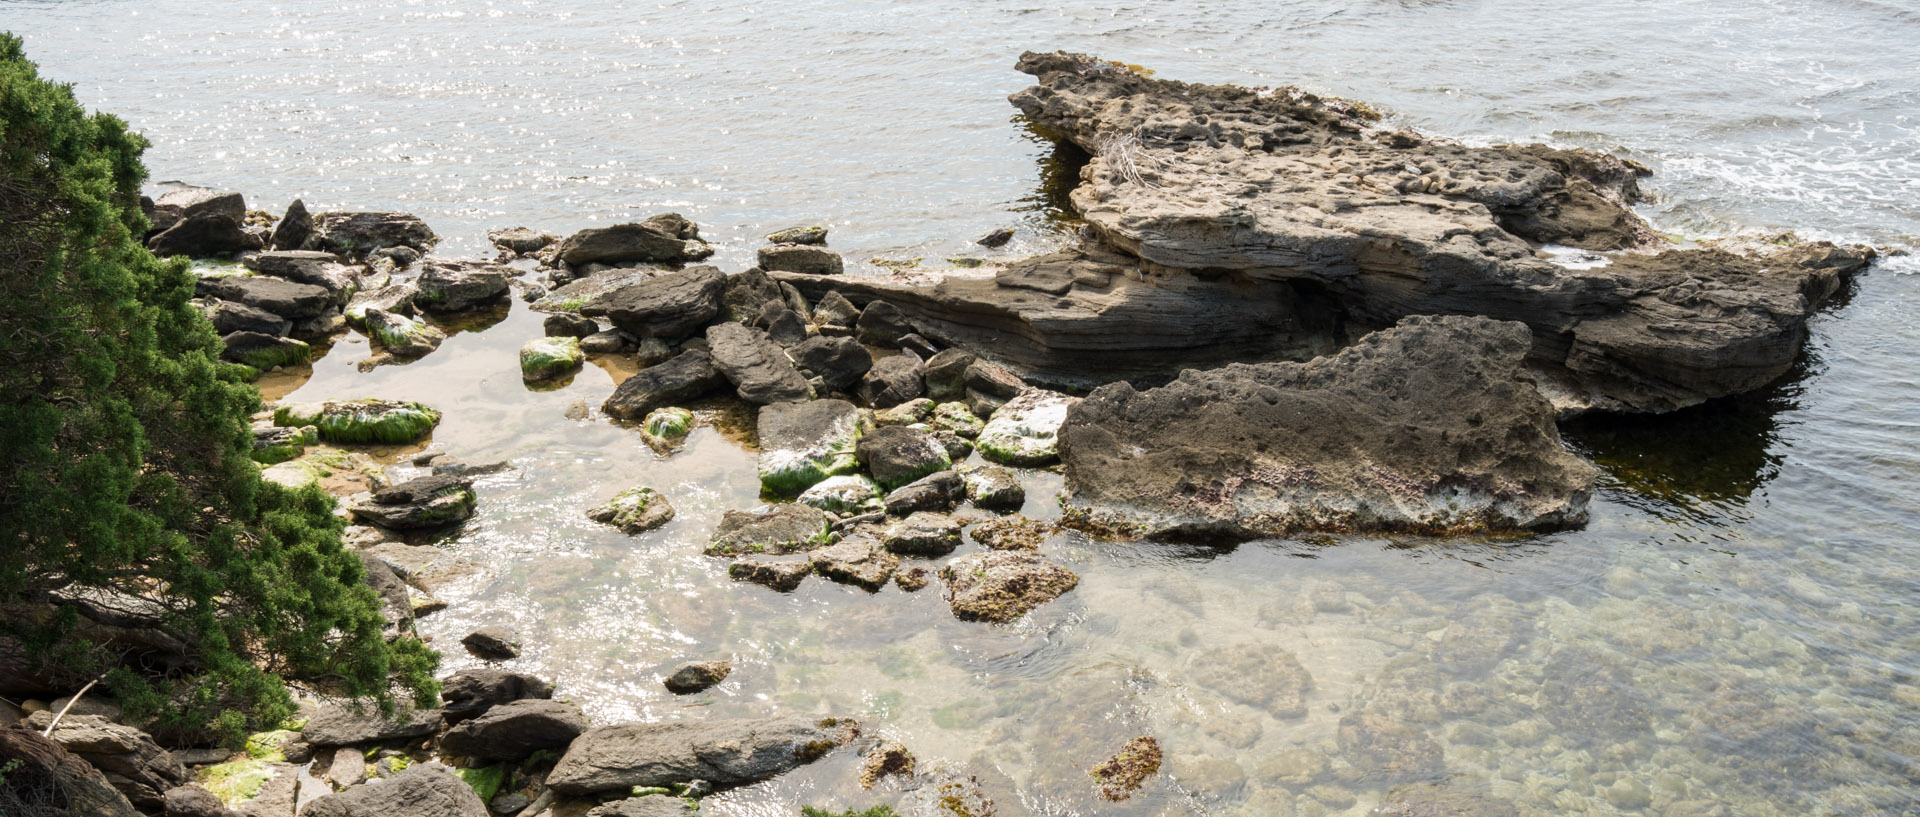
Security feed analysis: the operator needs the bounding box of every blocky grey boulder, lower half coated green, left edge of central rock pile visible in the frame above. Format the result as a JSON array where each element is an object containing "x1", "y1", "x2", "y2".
[{"x1": 758, "y1": 399, "x2": 870, "y2": 497}]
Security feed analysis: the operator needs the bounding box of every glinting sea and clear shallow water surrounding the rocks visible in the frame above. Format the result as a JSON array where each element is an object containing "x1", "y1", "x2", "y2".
[{"x1": 0, "y1": 0, "x2": 1920, "y2": 815}]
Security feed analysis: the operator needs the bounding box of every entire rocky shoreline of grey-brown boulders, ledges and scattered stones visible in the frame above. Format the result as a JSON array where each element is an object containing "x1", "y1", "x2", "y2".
[{"x1": 0, "y1": 54, "x2": 1872, "y2": 817}]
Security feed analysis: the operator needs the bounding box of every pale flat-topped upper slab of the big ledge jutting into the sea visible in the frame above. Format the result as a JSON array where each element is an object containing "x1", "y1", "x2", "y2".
[{"x1": 1006, "y1": 52, "x2": 1870, "y2": 410}]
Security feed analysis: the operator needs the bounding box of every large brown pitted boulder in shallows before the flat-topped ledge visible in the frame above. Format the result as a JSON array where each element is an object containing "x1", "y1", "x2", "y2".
[{"x1": 1059, "y1": 316, "x2": 1596, "y2": 537}]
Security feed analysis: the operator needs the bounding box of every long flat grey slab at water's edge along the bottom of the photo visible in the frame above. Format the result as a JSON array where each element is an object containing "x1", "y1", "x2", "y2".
[{"x1": 547, "y1": 717, "x2": 856, "y2": 798}]
